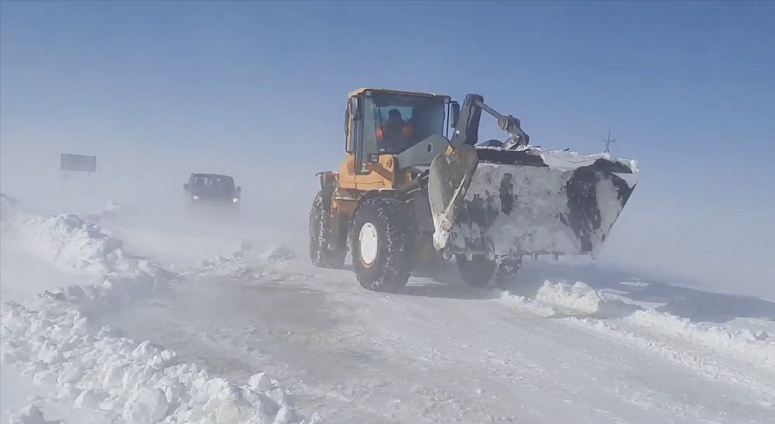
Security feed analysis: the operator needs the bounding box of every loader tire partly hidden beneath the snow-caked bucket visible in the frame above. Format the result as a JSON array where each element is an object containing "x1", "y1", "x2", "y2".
[{"x1": 455, "y1": 255, "x2": 522, "y2": 289}]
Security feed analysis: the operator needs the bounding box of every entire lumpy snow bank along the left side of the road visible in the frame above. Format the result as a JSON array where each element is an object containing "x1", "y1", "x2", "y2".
[{"x1": 0, "y1": 196, "x2": 310, "y2": 424}]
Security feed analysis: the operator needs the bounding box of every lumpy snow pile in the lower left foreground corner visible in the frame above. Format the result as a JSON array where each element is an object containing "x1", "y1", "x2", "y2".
[{"x1": 2, "y1": 300, "x2": 298, "y2": 424}]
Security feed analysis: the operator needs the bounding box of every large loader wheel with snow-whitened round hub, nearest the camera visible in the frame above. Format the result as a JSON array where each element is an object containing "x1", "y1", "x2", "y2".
[{"x1": 350, "y1": 197, "x2": 414, "y2": 292}]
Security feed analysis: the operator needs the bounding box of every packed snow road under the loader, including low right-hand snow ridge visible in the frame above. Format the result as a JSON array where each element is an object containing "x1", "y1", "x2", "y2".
[{"x1": 95, "y1": 250, "x2": 775, "y2": 424}]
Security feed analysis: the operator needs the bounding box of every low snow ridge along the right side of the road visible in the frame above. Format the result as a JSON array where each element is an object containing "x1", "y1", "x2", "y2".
[{"x1": 501, "y1": 281, "x2": 775, "y2": 370}]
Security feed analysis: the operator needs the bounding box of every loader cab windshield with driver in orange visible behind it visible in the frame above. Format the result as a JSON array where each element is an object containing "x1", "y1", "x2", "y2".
[{"x1": 366, "y1": 94, "x2": 446, "y2": 153}]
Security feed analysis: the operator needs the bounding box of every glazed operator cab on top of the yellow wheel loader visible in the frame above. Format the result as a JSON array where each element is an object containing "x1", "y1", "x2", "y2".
[{"x1": 345, "y1": 88, "x2": 460, "y2": 175}]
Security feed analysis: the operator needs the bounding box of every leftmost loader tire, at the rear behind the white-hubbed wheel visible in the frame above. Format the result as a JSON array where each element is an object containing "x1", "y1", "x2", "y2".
[{"x1": 309, "y1": 191, "x2": 347, "y2": 268}]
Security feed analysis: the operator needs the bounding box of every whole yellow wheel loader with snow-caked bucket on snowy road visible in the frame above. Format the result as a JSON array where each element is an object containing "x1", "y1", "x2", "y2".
[{"x1": 309, "y1": 88, "x2": 638, "y2": 292}]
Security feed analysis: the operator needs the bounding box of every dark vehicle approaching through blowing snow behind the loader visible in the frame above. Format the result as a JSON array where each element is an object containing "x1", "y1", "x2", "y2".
[{"x1": 183, "y1": 173, "x2": 242, "y2": 208}]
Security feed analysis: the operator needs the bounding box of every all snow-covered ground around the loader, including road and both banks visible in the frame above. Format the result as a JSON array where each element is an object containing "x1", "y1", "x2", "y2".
[{"x1": 0, "y1": 192, "x2": 775, "y2": 424}]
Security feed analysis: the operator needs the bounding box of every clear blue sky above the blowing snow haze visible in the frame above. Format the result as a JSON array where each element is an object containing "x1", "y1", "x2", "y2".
[{"x1": 0, "y1": 1, "x2": 775, "y2": 199}]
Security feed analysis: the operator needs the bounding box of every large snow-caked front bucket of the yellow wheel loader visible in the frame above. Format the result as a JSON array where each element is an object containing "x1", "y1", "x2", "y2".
[{"x1": 428, "y1": 146, "x2": 637, "y2": 257}]
